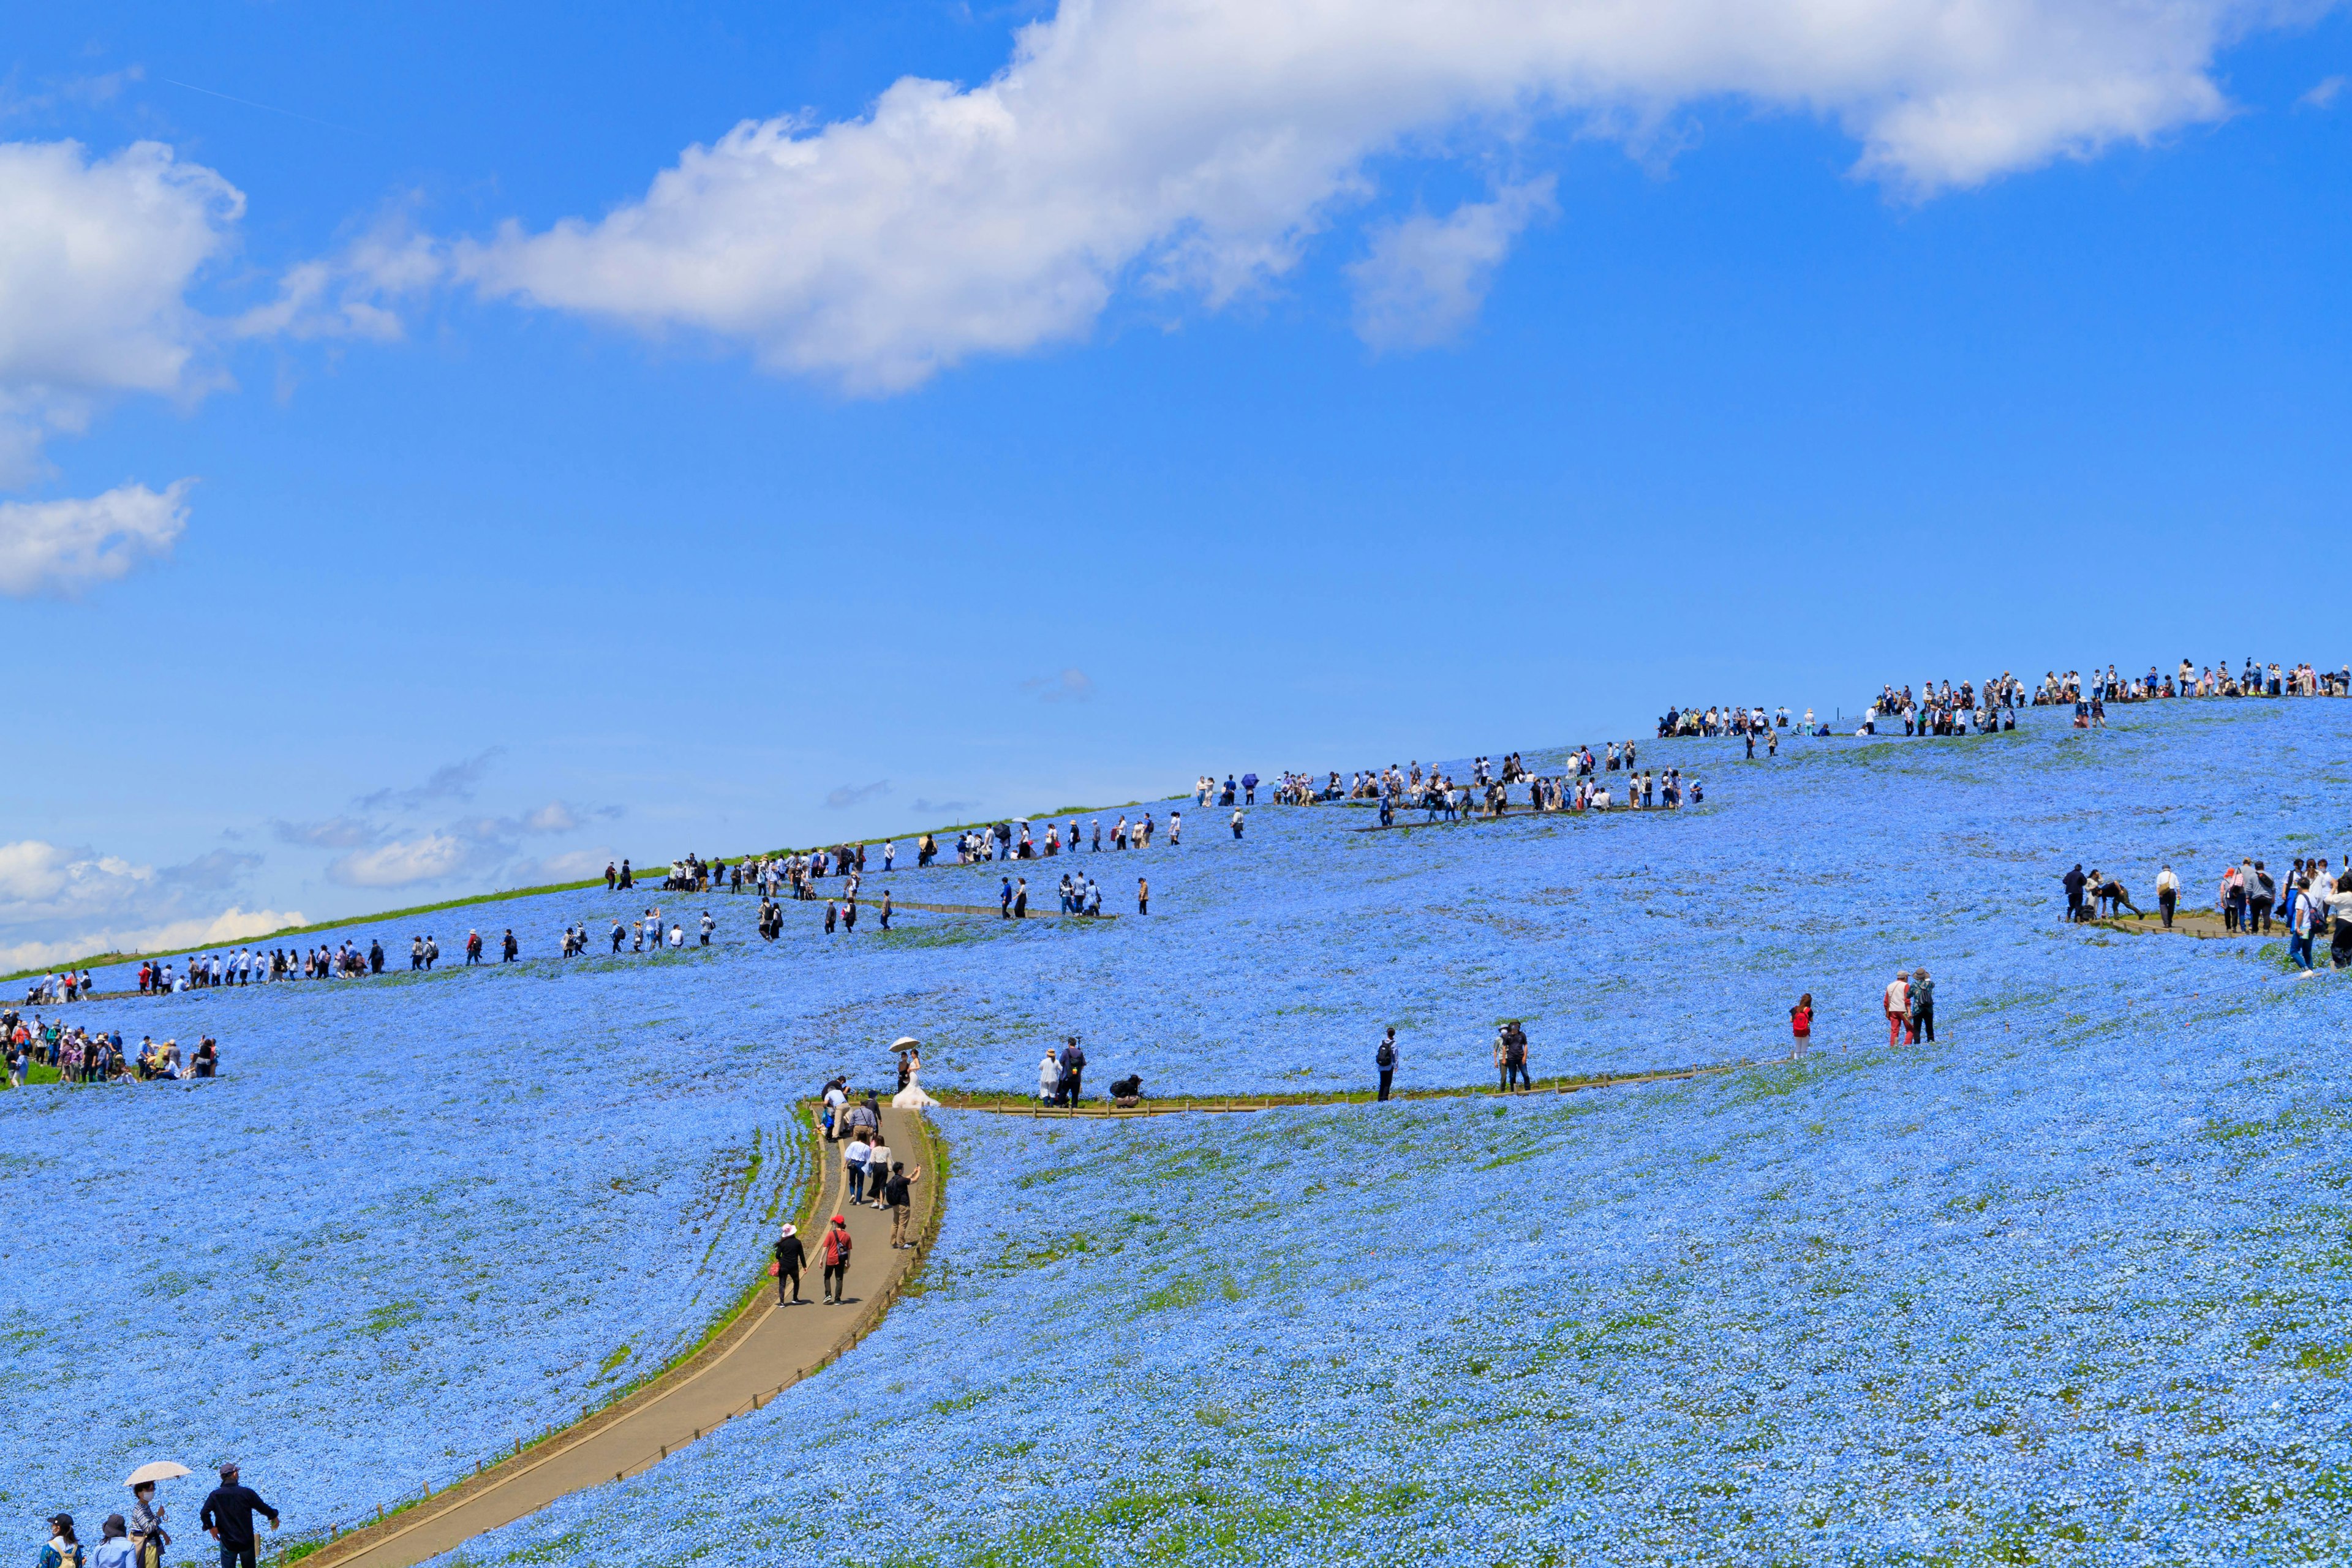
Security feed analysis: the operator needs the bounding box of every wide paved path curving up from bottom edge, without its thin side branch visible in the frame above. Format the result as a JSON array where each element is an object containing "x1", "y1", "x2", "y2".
[{"x1": 306, "y1": 1110, "x2": 941, "y2": 1568}]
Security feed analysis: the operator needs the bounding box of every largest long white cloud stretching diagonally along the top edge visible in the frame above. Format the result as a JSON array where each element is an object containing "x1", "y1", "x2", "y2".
[{"x1": 454, "y1": 0, "x2": 2277, "y2": 390}]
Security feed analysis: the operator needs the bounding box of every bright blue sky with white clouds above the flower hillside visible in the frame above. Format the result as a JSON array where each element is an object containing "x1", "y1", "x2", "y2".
[{"x1": 0, "y1": 0, "x2": 2352, "y2": 962}]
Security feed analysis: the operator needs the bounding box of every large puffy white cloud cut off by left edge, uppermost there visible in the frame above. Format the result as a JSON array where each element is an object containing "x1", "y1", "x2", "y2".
[{"x1": 0, "y1": 141, "x2": 244, "y2": 484}]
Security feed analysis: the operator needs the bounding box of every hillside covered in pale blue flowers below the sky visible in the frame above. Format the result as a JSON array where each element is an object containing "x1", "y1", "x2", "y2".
[{"x1": 0, "y1": 701, "x2": 2352, "y2": 1563}]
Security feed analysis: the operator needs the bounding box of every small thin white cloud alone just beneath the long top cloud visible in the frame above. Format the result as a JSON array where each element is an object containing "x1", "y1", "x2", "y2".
[{"x1": 1348, "y1": 179, "x2": 1555, "y2": 348}]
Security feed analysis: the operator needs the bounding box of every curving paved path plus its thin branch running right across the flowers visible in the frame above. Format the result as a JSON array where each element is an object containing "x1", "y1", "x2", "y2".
[{"x1": 303, "y1": 1060, "x2": 1752, "y2": 1568}]
